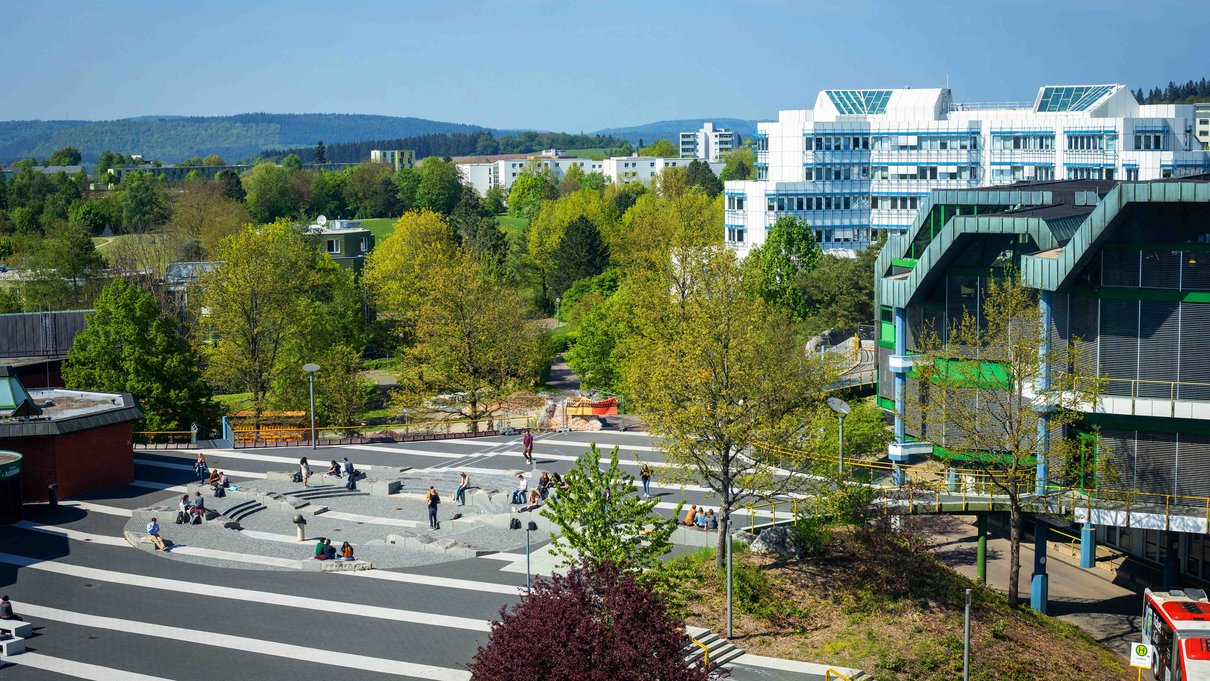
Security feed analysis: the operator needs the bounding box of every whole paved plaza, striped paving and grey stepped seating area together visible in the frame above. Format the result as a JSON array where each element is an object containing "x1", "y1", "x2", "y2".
[{"x1": 0, "y1": 432, "x2": 842, "y2": 681}]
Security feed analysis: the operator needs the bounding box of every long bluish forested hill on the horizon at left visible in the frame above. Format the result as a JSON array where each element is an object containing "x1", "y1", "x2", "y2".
[{"x1": 0, "y1": 114, "x2": 484, "y2": 163}]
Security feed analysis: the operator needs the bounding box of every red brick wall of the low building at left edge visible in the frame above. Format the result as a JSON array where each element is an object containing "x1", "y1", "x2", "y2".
[{"x1": 0, "y1": 423, "x2": 134, "y2": 503}]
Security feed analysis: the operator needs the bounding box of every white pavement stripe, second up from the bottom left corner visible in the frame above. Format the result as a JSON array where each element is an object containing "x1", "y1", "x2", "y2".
[{"x1": 22, "y1": 602, "x2": 471, "y2": 681}]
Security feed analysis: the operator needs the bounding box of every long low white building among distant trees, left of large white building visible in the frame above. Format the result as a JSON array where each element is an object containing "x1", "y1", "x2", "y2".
[{"x1": 457, "y1": 149, "x2": 724, "y2": 195}]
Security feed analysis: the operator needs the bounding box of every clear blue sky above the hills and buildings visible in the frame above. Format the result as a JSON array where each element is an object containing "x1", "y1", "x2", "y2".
[{"x1": 0, "y1": 0, "x2": 1210, "y2": 132}]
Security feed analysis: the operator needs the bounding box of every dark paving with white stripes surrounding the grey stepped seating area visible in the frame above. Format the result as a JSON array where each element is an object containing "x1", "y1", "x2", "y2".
[{"x1": 0, "y1": 433, "x2": 820, "y2": 681}]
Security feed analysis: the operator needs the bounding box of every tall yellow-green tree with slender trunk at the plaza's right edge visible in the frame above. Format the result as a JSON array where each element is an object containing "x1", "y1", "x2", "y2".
[{"x1": 621, "y1": 247, "x2": 829, "y2": 567}]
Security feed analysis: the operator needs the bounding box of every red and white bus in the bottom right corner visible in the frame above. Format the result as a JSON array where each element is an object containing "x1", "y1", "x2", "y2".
[{"x1": 1142, "y1": 589, "x2": 1210, "y2": 681}]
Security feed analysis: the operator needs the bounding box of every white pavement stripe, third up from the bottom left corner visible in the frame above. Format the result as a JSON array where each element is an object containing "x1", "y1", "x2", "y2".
[{"x1": 0, "y1": 553, "x2": 490, "y2": 633}]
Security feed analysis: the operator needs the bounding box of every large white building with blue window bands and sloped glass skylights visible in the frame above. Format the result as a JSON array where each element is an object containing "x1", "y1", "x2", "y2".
[{"x1": 724, "y1": 85, "x2": 1210, "y2": 255}]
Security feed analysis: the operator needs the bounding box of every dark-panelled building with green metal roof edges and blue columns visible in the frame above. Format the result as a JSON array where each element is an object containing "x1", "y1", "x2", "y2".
[{"x1": 875, "y1": 175, "x2": 1210, "y2": 587}]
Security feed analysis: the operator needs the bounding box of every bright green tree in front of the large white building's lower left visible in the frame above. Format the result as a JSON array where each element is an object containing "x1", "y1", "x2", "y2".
[{"x1": 744, "y1": 215, "x2": 827, "y2": 322}]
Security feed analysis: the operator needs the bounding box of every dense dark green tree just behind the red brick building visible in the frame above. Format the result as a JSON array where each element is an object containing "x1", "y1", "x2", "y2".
[{"x1": 63, "y1": 279, "x2": 218, "y2": 431}]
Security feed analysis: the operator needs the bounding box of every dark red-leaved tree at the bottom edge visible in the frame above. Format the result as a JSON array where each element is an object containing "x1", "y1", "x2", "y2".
[{"x1": 469, "y1": 562, "x2": 707, "y2": 681}]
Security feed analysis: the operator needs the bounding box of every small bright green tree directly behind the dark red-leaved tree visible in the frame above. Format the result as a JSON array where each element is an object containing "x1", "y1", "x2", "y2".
[{"x1": 542, "y1": 443, "x2": 680, "y2": 572}]
